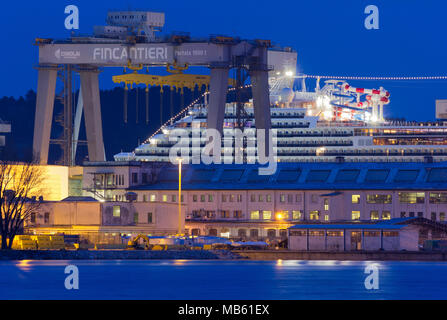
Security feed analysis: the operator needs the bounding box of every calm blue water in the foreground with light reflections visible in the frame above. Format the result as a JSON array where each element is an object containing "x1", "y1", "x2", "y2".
[{"x1": 0, "y1": 260, "x2": 447, "y2": 300}]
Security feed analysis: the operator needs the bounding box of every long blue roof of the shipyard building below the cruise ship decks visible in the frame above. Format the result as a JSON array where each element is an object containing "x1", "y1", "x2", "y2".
[{"x1": 131, "y1": 162, "x2": 447, "y2": 191}]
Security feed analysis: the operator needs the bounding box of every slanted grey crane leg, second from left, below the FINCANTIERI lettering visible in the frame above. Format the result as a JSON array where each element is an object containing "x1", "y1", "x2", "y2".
[{"x1": 79, "y1": 69, "x2": 106, "y2": 161}]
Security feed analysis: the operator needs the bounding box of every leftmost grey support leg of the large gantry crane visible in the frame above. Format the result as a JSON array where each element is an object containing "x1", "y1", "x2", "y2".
[{"x1": 33, "y1": 66, "x2": 57, "y2": 164}]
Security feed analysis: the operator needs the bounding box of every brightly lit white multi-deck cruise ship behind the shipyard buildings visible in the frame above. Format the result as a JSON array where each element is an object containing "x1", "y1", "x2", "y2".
[{"x1": 114, "y1": 78, "x2": 447, "y2": 162}]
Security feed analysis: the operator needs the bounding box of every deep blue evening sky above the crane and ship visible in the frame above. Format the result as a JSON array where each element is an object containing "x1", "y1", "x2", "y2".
[{"x1": 0, "y1": 0, "x2": 447, "y2": 120}]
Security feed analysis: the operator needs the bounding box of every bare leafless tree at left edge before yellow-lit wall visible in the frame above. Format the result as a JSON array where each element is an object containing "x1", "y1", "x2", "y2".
[{"x1": 0, "y1": 161, "x2": 43, "y2": 250}]
